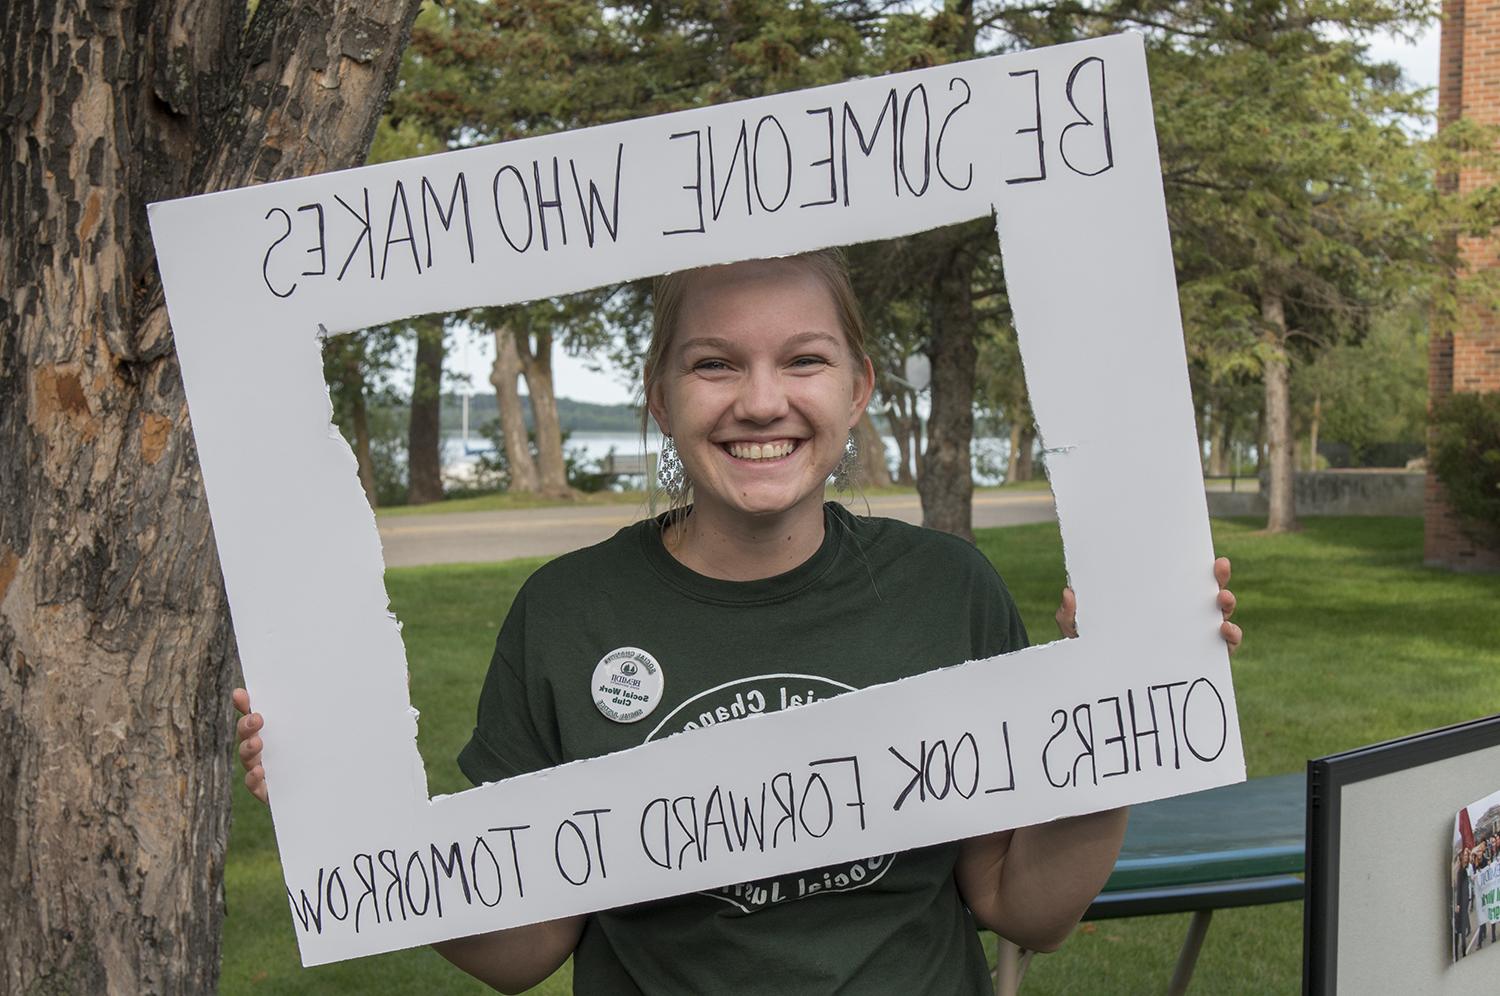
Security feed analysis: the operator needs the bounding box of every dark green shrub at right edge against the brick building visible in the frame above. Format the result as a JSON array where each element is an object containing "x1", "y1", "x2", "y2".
[{"x1": 1431, "y1": 393, "x2": 1500, "y2": 545}]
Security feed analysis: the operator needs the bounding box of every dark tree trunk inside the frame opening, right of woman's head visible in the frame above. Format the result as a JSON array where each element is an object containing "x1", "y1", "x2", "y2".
[{"x1": 917, "y1": 245, "x2": 980, "y2": 542}]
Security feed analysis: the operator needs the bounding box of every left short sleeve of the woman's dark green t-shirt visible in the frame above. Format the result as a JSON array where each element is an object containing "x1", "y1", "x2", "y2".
[{"x1": 459, "y1": 590, "x2": 563, "y2": 785}]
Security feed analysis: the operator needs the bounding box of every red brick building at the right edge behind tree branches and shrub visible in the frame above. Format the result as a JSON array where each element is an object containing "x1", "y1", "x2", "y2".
[{"x1": 1424, "y1": 0, "x2": 1500, "y2": 570}]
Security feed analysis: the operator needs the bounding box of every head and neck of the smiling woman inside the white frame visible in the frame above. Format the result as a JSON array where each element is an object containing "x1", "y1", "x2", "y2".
[{"x1": 645, "y1": 252, "x2": 875, "y2": 581}]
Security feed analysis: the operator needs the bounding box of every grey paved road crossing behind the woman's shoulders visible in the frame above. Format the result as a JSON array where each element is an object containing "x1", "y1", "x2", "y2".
[{"x1": 380, "y1": 491, "x2": 1058, "y2": 567}]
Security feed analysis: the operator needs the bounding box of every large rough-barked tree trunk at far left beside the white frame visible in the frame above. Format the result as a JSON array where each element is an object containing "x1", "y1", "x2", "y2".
[{"x1": 0, "y1": 0, "x2": 417, "y2": 995}]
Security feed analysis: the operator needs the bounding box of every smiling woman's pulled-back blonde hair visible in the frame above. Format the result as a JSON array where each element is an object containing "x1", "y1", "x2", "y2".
[{"x1": 641, "y1": 246, "x2": 870, "y2": 518}]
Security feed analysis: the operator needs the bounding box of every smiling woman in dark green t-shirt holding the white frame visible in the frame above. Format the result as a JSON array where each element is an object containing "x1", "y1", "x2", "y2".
[{"x1": 236, "y1": 251, "x2": 1239, "y2": 995}]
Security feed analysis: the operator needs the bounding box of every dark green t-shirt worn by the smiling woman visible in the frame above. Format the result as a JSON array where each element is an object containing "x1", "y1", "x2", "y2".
[{"x1": 459, "y1": 504, "x2": 1026, "y2": 996}]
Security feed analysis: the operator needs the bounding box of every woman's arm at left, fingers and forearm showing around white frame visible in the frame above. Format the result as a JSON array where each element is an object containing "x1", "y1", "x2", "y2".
[{"x1": 233, "y1": 689, "x2": 588, "y2": 993}]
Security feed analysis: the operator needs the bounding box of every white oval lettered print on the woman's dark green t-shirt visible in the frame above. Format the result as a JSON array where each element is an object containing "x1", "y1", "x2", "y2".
[{"x1": 647, "y1": 674, "x2": 896, "y2": 914}]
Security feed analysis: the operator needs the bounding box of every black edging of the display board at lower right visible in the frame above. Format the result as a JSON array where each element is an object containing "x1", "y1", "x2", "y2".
[{"x1": 1302, "y1": 714, "x2": 1500, "y2": 996}]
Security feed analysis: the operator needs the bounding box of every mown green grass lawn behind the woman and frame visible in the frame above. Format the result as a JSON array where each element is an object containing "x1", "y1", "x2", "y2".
[{"x1": 222, "y1": 519, "x2": 1500, "y2": 996}]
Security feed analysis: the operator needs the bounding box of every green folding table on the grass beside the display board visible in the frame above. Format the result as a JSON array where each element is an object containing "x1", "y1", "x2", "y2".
[{"x1": 996, "y1": 773, "x2": 1307, "y2": 996}]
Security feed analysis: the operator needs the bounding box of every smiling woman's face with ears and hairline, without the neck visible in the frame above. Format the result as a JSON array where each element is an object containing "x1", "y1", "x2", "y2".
[{"x1": 650, "y1": 260, "x2": 875, "y2": 519}]
